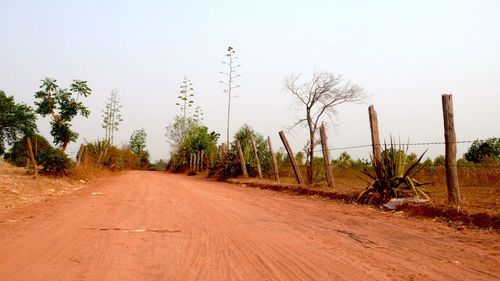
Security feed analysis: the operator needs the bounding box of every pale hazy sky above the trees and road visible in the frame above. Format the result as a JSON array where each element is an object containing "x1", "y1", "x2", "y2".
[{"x1": 0, "y1": 0, "x2": 500, "y2": 160}]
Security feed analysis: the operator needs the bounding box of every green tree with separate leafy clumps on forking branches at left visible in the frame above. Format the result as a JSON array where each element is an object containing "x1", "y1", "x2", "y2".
[{"x1": 35, "y1": 78, "x2": 92, "y2": 152}]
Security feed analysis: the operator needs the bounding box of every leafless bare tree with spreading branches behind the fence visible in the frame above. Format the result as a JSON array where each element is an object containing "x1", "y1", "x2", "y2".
[{"x1": 285, "y1": 72, "x2": 366, "y2": 183}]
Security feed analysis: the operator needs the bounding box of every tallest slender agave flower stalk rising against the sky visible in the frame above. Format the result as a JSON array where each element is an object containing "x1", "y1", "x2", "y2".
[{"x1": 219, "y1": 46, "x2": 241, "y2": 144}]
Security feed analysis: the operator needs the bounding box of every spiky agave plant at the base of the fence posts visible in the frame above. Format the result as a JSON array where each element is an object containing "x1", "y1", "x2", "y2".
[{"x1": 358, "y1": 138, "x2": 430, "y2": 203}]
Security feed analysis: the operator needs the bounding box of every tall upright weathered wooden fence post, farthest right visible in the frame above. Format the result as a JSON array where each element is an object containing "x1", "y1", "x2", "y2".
[{"x1": 442, "y1": 94, "x2": 460, "y2": 206}]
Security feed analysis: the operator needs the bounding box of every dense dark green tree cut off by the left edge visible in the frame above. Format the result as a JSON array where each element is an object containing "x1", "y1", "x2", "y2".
[{"x1": 0, "y1": 90, "x2": 37, "y2": 156}]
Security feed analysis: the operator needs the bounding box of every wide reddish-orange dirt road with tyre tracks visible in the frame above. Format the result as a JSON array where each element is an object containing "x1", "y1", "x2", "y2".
[{"x1": 0, "y1": 172, "x2": 500, "y2": 281}]
